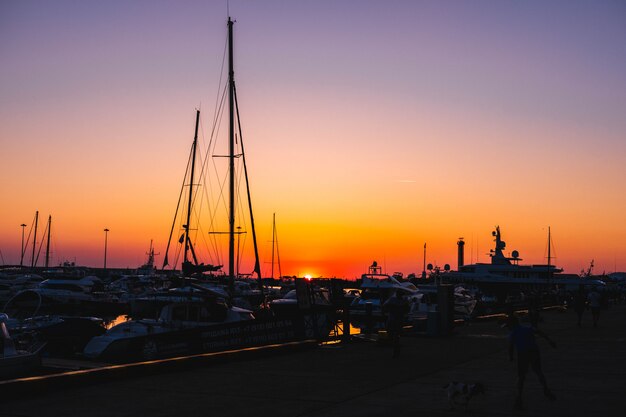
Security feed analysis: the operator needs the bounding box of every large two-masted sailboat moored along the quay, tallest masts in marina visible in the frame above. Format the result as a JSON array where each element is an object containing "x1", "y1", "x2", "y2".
[{"x1": 83, "y1": 18, "x2": 314, "y2": 362}]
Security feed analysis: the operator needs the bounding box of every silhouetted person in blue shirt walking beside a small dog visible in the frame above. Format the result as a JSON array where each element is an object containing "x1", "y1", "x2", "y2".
[{"x1": 507, "y1": 315, "x2": 556, "y2": 410}]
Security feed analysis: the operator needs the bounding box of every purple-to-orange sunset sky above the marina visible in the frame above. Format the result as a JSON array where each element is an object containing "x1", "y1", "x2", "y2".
[{"x1": 0, "y1": 0, "x2": 626, "y2": 278}]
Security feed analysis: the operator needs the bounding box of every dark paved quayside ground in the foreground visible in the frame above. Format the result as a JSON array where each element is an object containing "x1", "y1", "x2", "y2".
[{"x1": 0, "y1": 306, "x2": 626, "y2": 417}]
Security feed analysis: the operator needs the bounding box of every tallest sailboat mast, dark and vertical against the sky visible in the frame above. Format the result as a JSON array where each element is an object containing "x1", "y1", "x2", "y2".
[{"x1": 228, "y1": 17, "x2": 235, "y2": 294}]
